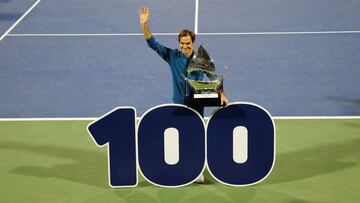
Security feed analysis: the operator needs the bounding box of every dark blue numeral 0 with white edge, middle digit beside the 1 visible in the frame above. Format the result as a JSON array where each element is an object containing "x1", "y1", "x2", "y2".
[{"x1": 138, "y1": 104, "x2": 205, "y2": 187}]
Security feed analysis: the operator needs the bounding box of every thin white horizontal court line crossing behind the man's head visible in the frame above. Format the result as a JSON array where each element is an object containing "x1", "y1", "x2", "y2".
[{"x1": 7, "y1": 30, "x2": 360, "y2": 37}]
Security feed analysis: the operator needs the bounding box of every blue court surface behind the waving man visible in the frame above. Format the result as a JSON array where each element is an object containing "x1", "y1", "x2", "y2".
[{"x1": 0, "y1": 0, "x2": 360, "y2": 118}]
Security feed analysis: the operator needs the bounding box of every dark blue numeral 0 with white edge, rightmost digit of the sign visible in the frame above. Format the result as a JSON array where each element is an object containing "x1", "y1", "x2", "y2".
[{"x1": 207, "y1": 103, "x2": 275, "y2": 186}]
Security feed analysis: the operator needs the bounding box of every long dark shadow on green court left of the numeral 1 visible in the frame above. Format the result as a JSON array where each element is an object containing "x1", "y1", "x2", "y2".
[{"x1": 0, "y1": 142, "x2": 109, "y2": 188}]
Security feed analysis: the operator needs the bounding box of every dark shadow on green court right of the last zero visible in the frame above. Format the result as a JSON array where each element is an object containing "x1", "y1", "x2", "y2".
[{"x1": 262, "y1": 139, "x2": 360, "y2": 184}]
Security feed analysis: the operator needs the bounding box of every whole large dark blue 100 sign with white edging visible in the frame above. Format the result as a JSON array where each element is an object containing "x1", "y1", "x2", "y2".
[{"x1": 88, "y1": 103, "x2": 275, "y2": 187}]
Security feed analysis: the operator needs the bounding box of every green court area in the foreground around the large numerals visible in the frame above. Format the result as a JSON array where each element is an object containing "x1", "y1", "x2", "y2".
[{"x1": 0, "y1": 119, "x2": 360, "y2": 203}]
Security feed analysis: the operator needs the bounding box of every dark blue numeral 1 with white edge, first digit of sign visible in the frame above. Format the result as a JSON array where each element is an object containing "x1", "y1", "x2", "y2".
[{"x1": 88, "y1": 107, "x2": 138, "y2": 187}]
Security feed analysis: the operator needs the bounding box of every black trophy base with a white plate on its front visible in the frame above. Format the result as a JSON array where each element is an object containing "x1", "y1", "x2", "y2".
[{"x1": 187, "y1": 93, "x2": 223, "y2": 107}]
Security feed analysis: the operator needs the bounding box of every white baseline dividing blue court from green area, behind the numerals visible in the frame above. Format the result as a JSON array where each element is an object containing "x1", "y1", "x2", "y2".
[{"x1": 0, "y1": 116, "x2": 360, "y2": 122}]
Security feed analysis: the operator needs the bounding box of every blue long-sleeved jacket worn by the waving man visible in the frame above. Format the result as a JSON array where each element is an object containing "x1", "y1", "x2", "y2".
[{"x1": 146, "y1": 36, "x2": 203, "y2": 104}]
